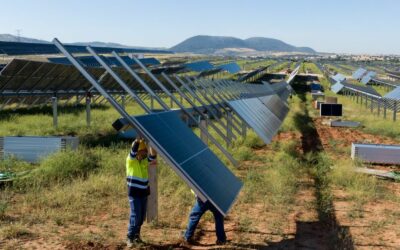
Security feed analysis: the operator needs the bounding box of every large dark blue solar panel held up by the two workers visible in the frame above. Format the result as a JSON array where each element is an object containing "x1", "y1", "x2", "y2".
[{"x1": 135, "y1": 111, "x2": 242, "y2": 214}]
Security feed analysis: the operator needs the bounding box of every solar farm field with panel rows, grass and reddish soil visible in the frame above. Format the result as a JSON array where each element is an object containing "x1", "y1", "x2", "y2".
[{"x1": 0, "y1": 41, "x2": 400, "y2": 249}]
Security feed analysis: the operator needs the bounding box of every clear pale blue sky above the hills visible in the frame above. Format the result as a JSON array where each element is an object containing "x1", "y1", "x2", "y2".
[{"x1": 0, "y1": 0, "x2": 400, "y2": 54}]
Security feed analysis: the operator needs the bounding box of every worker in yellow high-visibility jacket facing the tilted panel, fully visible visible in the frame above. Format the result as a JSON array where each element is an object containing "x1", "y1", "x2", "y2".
[{"x1": 126, "y1": 138, "x2": 157, "y2": 247}]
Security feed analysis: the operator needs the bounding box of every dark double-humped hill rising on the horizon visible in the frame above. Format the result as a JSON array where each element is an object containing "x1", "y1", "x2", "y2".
[{"x1": 170, "y1": 36, "x2": 316, "y2": 54}]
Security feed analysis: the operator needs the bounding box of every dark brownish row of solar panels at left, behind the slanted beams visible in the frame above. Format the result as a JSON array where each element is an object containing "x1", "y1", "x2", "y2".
[{"x1": 0, "y1": 59, "x2": 172, "y2": 94}]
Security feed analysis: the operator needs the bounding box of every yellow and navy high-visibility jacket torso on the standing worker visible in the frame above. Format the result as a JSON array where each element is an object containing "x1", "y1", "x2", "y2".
[{"x1": 126, "y1": 155, "x2": 149, "y2": 196}]
